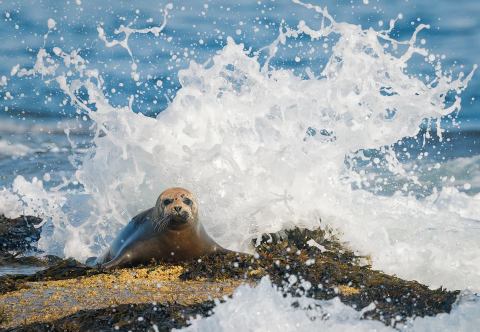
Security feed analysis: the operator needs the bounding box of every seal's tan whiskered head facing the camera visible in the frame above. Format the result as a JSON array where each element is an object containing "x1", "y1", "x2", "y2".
[{"x1": 156, "y1": 188, "x2": 198, "y2": 228}]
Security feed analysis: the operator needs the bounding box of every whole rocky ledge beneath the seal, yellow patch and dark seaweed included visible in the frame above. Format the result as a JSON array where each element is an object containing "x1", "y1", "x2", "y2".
[{"x1": 0, "y1": 217, "x2": 459, "y2": 331}]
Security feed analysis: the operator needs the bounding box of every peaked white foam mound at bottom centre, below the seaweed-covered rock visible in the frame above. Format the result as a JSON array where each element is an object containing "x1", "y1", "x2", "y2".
[{"x1": 178, "y1": 278, "x2": 395, "y2": 332}]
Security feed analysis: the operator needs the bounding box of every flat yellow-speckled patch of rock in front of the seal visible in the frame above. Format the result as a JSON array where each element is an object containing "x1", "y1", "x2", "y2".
[{"x1": 0, "y1": 265, "x2": 241, "y2": 331}]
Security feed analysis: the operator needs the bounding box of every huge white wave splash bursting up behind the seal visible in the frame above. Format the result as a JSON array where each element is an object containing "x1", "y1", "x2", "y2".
[{"x1": 4, "y1": 1, "x2": 480, "y2": 288}]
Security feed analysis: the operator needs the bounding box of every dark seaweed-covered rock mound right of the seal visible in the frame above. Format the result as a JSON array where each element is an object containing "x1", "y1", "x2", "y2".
[{"x1": 182, "y1": 228, "x2": 459, "y2": 325}]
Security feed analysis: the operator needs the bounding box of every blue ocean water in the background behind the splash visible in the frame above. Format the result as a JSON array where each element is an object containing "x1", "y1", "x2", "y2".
[{"x1": 0, "y1": 0, "x2": 480, "y2": 192}]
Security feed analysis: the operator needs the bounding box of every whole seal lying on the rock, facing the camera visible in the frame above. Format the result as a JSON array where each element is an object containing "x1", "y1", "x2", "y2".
[{"x1": 97, "y1": 188, "x2": 228, "y2": 269}]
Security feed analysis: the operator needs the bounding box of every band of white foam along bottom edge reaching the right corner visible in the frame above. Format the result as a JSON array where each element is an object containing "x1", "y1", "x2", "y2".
[{"x1": 178, "y1": 278, "x2": 480, "y2": 332}]
